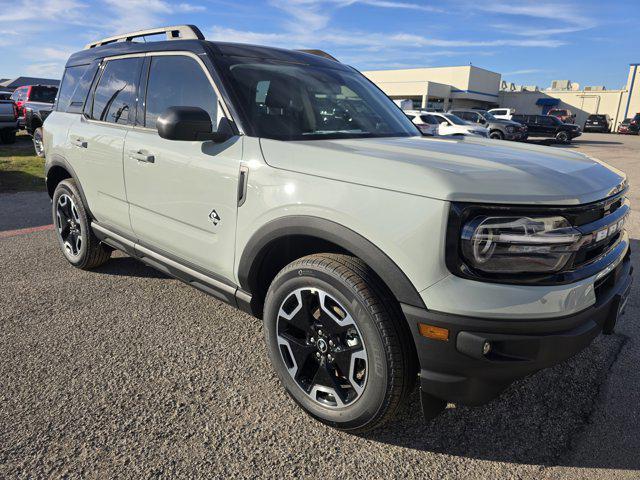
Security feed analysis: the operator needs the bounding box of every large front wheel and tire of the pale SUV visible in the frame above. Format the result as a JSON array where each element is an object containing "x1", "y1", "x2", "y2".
[{"x1": 264, "y1": 254, "x2": 417, "y2": 432}]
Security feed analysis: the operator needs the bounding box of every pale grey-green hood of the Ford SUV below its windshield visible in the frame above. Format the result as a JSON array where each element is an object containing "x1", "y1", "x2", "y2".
[{"x1": 260, "y1": 136, "x2": 625, "y2": 205}]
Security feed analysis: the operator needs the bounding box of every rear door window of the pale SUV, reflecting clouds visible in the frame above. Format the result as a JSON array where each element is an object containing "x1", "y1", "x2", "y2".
[{"x1": 91, "y1": 58, "x2": 142, "y2": 125}]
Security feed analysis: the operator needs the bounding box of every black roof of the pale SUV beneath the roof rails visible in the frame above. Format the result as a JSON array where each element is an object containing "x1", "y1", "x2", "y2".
[{"x1": 67, "y1": 40, "x2": 349, "y2": 69}]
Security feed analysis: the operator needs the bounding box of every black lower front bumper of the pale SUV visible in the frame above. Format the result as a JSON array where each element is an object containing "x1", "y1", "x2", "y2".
[{"x1": 402, "y1": 252, "x2": 632, "y2": 405}]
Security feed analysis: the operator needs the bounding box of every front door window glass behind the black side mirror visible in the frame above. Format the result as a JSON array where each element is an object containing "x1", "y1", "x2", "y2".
[{"x1": 144, "y1": 55, "x2": 218, "y2": 129}]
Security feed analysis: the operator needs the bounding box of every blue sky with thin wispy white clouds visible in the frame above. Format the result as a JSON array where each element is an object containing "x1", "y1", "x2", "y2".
[{"x1": 0, "y1": 0, "x2": 640, "y2": 89}]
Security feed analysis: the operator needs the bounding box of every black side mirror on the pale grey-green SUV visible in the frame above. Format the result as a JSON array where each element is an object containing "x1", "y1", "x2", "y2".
[{"x1": 156, "y1": 107, "x2": 233, "y2": 143}]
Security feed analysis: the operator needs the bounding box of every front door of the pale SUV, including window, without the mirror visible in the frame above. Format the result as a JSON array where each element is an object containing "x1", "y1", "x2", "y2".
[{"x1": 124, "y1": 53, "x2": 242, "y2": 279}]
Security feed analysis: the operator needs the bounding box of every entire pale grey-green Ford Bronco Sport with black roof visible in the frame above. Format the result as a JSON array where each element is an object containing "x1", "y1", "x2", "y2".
[{"x1": 44, "y1": 26, "x2": 631, "y2": 431}]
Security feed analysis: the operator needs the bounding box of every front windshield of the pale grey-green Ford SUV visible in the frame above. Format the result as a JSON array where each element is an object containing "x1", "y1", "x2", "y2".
[{"x1": 215, "y1": 57, "x2": 420, "y2": 140}]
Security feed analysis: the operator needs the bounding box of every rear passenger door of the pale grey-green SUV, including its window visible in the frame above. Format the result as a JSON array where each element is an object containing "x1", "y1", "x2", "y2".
[{"x1": 69, "y1": 56, "x2": 144, "y2": 234}]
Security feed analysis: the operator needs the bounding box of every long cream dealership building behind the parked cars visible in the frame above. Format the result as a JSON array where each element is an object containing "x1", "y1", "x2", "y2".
[{"x1": 362, "y1": 63, "x2": 640, "y2": 132}]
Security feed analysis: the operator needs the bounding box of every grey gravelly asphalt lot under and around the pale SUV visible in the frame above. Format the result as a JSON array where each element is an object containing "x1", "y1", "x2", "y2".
[{"x1": 0, "y1": 134, "x2": 640, "y2": 478}]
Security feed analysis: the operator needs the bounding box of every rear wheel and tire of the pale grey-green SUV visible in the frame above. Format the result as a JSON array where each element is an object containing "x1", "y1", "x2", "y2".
[{"x1": 52, "y1": 178, "x2": 112, "y2": 270}]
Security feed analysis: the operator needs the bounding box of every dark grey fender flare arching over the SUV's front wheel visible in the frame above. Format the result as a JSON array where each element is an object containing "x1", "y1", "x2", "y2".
[{"x1": 238, "y1": 215, "x2": 426, "y2": 308}]
